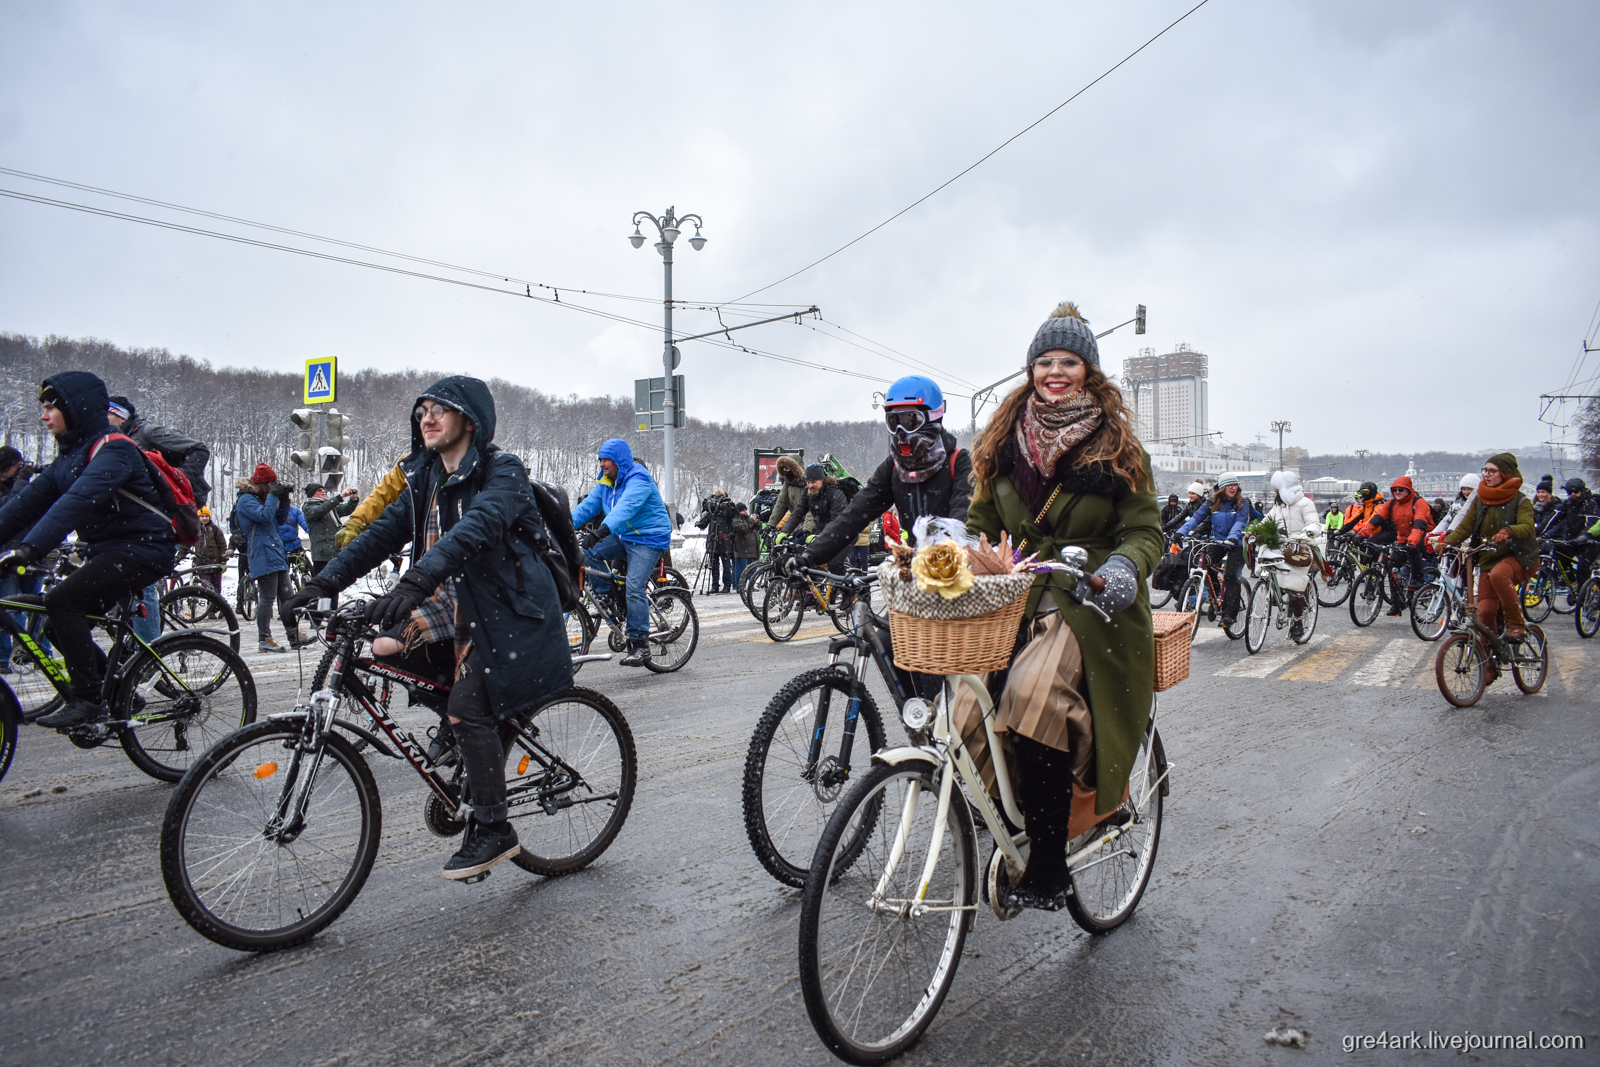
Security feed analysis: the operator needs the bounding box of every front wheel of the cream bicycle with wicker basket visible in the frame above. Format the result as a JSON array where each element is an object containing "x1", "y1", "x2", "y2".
[{"x1": 800, "y1": 760, "x2": 978, "y2": 1064}]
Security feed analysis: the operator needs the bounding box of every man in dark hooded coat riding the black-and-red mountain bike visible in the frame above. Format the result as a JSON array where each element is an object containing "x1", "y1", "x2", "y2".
[{"x1": 285, "y1": 374, "x2": 573, "y2": 880}]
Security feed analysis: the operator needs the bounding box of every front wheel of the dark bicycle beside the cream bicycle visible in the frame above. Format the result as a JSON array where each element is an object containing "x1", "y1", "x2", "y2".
[{"x1": 741, "y1": 667, "x2": 888, "y2": 889}]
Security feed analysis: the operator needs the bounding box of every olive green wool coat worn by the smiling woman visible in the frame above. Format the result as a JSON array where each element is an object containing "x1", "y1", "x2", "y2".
[{"x1": 966, "y1": 453, "x2": 1166, "y2": 814}]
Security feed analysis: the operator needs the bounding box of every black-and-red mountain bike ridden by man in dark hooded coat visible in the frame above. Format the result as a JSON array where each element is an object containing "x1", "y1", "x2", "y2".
[{"x1": 160, "y1": 603, "x2": 638, "y2": 952}]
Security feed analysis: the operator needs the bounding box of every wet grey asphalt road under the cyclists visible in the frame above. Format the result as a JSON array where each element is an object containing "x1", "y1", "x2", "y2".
[{"x1": 0, "y1": 597, "x2": 1600, "y2": 1067}]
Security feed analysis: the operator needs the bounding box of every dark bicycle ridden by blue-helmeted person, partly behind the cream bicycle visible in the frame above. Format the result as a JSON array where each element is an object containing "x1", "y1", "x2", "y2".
[{"x1": 742, "y1": 571, "x2": 910, "y2": 888}]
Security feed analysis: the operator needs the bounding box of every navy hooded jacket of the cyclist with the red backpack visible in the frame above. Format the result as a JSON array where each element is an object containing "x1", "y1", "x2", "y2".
[{"x1": 0, "y1": 371, "x2": 178, "y2": 569}]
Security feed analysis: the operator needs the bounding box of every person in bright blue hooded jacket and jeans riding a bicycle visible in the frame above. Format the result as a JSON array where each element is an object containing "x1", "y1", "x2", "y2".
[{"x1": 573, "y1": 437, "x2": 672, "y2": 667}]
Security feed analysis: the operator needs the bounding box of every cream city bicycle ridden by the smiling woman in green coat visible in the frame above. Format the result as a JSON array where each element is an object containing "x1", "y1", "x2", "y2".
[{"x1": 800, "y1": 563, "x2": 1170, "y2": 1064}]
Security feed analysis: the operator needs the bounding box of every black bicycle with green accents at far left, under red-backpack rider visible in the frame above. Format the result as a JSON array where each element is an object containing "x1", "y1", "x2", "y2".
[{"x1": 0, "y1": 566, "x2": 256, "y2": 782}]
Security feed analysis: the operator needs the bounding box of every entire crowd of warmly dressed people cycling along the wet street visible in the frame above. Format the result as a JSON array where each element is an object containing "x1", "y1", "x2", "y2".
[{"x1": 0, "y1": 304, "x2": 1600, "y2": 909}]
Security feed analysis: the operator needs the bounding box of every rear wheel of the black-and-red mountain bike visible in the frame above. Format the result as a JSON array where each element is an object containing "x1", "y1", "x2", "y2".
[{"x1": 506, "y1": 684, "x2": 636, "y2": 875}]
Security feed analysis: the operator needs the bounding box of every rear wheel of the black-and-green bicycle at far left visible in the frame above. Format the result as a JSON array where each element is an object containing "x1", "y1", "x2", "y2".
[{"x1": 115, "y1": 632, "x2": 256, "y2": 782}]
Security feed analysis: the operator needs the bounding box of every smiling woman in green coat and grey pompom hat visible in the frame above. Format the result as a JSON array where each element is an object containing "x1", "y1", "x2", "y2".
[{"x1": 957, "y1": 304, "x2": 1165, "y2": 910}]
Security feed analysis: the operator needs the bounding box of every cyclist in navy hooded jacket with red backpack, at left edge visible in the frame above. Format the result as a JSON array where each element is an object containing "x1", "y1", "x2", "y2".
[{"x1": 0, "y1": 371, "x2": 178, "y2": 726}]
